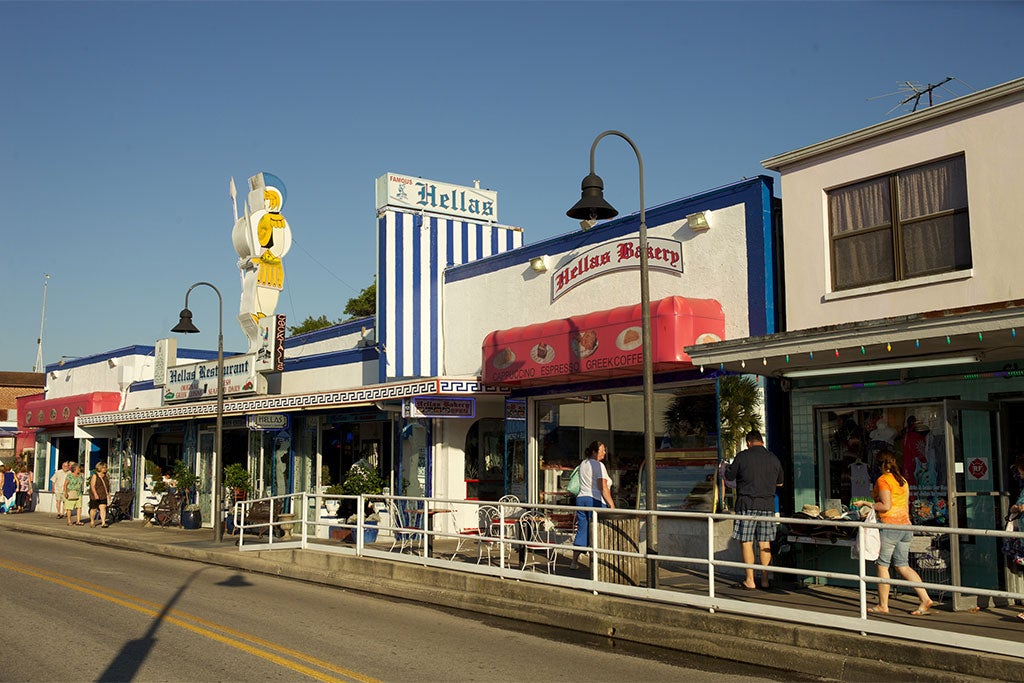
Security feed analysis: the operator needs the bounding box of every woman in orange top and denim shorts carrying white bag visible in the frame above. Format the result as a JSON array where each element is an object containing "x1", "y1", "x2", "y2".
[{"x1": 857, "y1": 451, "x2": 935, "y2": 616}]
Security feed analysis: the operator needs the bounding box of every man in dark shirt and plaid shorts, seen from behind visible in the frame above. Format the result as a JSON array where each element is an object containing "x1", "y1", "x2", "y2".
[{"x1": 725, "y1": 429, "x2": 782, "y2": 591}]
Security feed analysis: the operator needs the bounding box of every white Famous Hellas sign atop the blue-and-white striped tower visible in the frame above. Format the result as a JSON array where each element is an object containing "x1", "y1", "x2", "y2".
[{"x1": 377, "y1": 173, "x2": 498, "y2": 222}]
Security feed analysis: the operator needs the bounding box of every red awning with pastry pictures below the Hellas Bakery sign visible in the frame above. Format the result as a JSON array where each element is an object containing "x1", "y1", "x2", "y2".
[{"x1": 482, "y1": 297, "x2": 725, "y2": 386}]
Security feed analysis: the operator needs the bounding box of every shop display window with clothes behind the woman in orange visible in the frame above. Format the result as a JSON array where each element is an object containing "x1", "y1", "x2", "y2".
[{"x1": 816, "y1": 403, "x2": 948, "y2": 526}]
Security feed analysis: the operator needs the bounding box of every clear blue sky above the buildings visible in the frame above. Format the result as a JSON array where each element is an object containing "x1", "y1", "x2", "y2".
[{"x1": 0, "y1": 2, "x2": 1024, "y2": 371}]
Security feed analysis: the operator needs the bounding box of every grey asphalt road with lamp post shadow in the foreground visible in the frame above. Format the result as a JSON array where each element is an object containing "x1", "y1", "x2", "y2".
[{"x1": 0, "y1": 533, "x2": 815, "y2": 683}]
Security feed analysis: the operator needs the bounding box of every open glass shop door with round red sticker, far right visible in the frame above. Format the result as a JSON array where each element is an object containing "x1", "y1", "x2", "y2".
[{"x1": 943, "y1": 400, "x2": 1009, "y2": 610}]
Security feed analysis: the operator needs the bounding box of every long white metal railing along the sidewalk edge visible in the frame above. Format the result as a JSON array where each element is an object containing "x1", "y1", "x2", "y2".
[{"x1": 233, "y1": 494, "x2": 1024, "y2": 658}]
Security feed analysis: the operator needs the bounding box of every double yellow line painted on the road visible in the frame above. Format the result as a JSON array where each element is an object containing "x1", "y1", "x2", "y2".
[{"x1": 0, "y1": 559, "x2": 379, "y2": 683}]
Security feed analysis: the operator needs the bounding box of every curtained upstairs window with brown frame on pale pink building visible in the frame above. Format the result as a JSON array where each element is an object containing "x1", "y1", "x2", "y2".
[{"x1": 827, "y1": 156, "x2": 971, "y2": 290}]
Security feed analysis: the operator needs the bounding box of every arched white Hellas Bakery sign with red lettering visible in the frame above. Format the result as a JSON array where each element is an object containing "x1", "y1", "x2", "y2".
[{"x1": 551, "y1": 238, "x2": 683, "y2": 301}]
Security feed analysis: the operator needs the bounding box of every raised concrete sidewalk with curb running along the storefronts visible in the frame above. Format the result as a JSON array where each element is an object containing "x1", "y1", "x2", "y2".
[{"x1": 0, "y1": 512, "x2": 1024, "y2": 682}]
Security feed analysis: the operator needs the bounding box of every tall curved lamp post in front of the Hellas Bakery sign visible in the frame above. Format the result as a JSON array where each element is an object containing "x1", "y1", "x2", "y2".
[{"x1": 565, "y1": 130, "x2": 657, "y2": 588}]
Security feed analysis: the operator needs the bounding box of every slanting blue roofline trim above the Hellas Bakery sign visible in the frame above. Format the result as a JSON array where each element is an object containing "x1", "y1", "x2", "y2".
[{"x1": 444, "y1": 175, "x2": 773, "y2": 284}]
